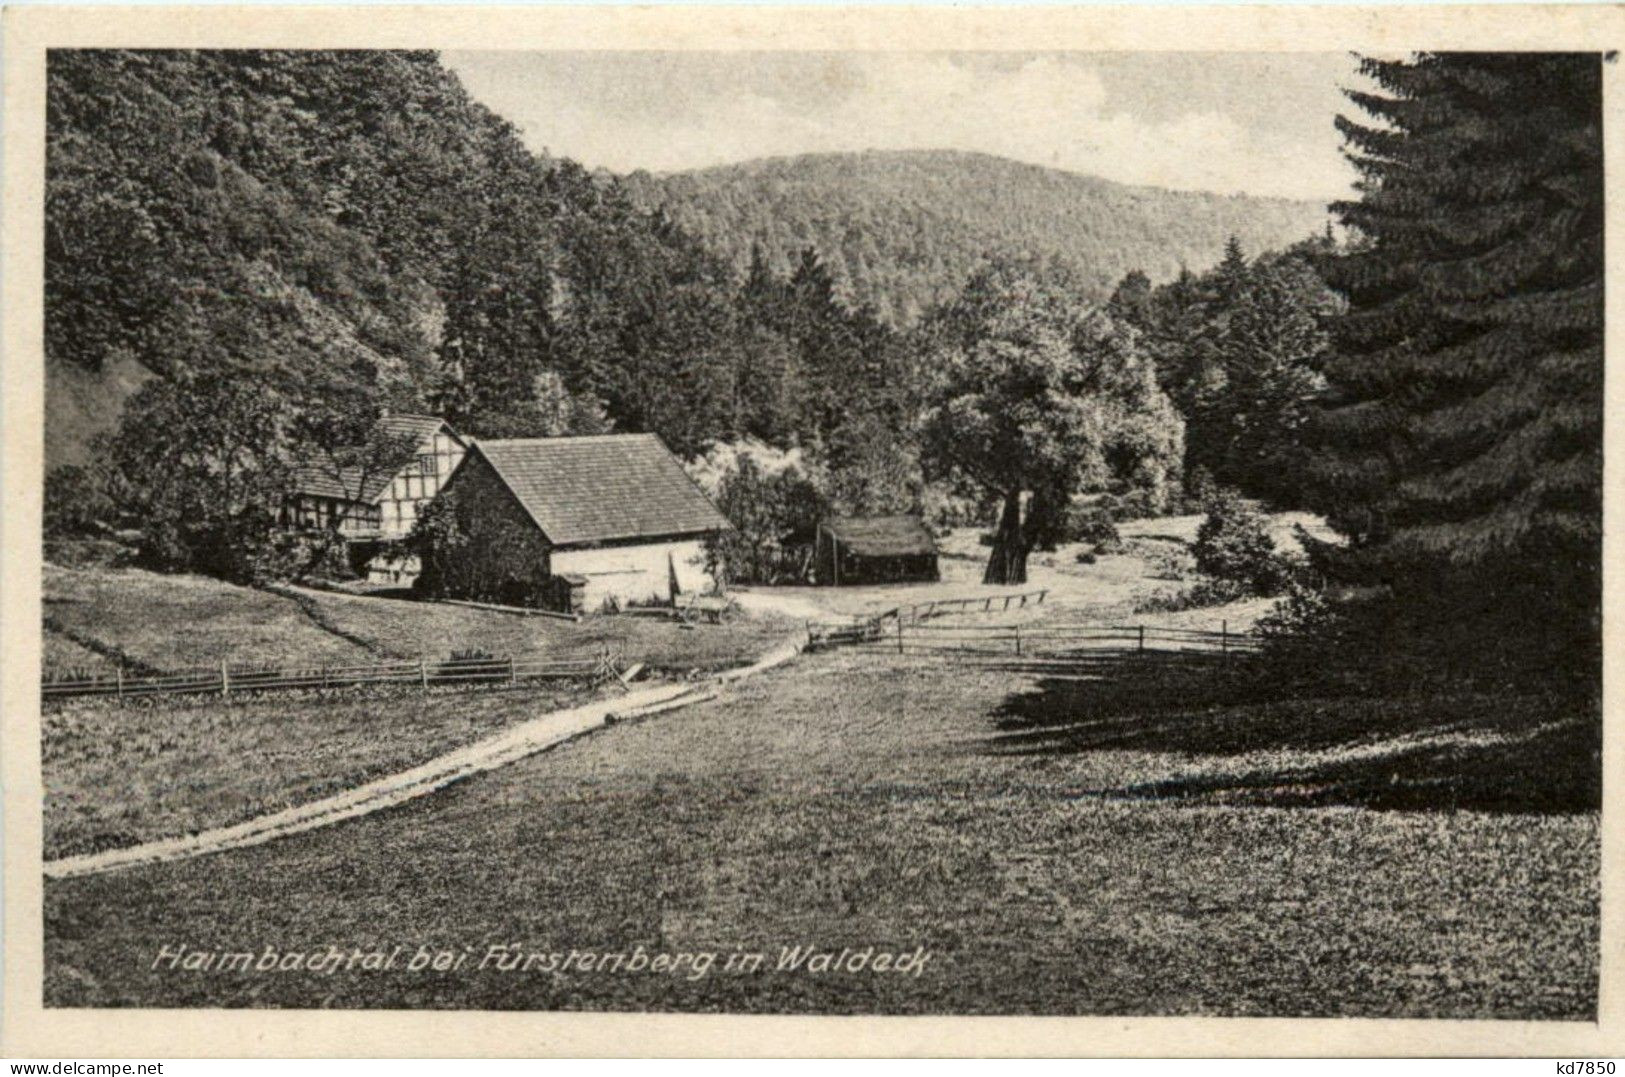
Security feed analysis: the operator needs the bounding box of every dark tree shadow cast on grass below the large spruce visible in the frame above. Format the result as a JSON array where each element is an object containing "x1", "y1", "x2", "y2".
[{"x1": 985, "y1": 660, "x2": 1602, "y2": 814}]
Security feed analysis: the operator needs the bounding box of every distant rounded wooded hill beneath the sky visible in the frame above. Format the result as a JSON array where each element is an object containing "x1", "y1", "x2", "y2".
[{"x1": 627, "y1": 149, "x2": 1329, "y2": 325}]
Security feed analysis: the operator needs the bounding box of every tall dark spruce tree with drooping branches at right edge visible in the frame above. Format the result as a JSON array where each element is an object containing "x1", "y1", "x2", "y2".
[{"x1": 1311, "y1": 54, "x2": 1604, "y2": 671}]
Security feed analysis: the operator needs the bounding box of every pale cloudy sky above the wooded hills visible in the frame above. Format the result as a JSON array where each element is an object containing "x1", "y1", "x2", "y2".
[{"x1": 444, "y1": 52, "x2": 1359, "y2": 200}]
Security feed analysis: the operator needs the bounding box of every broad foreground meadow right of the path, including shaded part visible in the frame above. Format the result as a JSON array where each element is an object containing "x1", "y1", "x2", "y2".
[{"x1": 46, "y1": 653, "x2": 1599, "y2": 1020}]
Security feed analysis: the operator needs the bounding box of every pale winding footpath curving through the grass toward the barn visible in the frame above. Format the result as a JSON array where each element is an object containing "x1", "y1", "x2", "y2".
[{"x1": 44, "y1": 642, "x2": 803, "y2": 879}]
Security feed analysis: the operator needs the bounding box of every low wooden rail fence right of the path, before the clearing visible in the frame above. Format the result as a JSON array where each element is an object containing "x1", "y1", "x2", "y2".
[{"x1": 808, "y1": 616, "x2": 1259, "y2": 661}]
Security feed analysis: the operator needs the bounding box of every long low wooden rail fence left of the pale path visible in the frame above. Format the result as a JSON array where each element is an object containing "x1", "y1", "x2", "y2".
[{"x1": 39, "y1": 650, "x2": 624, "y2": 700}]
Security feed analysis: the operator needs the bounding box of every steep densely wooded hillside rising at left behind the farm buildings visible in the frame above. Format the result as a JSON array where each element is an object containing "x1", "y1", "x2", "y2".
[{"x1": 46, "y1": 50, "x2": 949, "y2": 575}]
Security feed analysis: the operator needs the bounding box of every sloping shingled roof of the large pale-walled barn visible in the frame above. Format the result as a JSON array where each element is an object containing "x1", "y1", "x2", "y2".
[{"x1": 473, "y1": 434, "x2": 728, "y2": 546}]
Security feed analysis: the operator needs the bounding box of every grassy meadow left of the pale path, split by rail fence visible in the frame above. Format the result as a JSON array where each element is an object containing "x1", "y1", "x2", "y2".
[{"x1": 41, "y1": 565, "x2": 798, "y2": 858}]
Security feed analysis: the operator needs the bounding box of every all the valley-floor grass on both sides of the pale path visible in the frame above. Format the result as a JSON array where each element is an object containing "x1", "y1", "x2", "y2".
[{"x1": 44, "y1": 520, "x2": 1601, "y2": 1020}]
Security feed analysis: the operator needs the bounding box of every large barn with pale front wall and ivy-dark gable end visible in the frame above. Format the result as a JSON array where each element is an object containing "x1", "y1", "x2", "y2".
[{"x1": 419, "y1": 434, "x2": 728, "y2": 612}]
